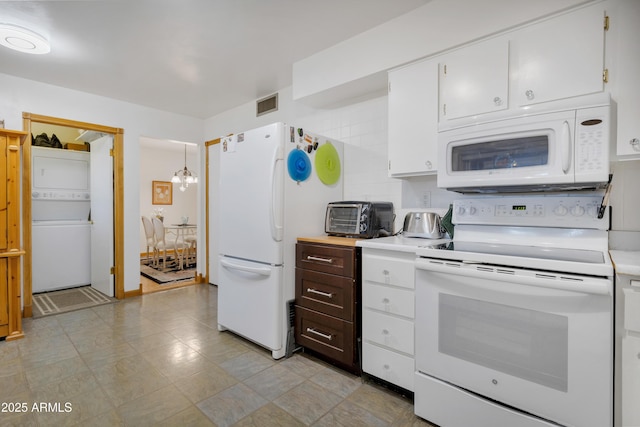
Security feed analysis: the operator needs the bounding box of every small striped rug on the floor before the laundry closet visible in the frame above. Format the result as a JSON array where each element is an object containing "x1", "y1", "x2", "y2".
[{"x1": 33, "y1": 286, "x2": 118, "y2": 317}]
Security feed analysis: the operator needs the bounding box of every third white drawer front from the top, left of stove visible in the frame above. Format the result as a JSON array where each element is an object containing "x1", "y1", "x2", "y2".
[{"x1": 362, "y1": 309, "x2": 414, "y2": 355}]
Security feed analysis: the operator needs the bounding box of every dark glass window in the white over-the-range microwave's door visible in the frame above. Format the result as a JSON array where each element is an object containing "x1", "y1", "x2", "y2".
[{"x1": 451, "y1": 135, "x2": 549, "y2": 172}]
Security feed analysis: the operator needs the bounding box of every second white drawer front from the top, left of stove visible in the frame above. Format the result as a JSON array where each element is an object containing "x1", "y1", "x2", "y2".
[{"x1": 362, "y1": 282, "x2": 415, "y2": 319}]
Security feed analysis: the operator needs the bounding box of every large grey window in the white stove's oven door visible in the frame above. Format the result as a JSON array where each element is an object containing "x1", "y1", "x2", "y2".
[{"x1": 438, "y1": 294, "x2": 569, "y2": 392}]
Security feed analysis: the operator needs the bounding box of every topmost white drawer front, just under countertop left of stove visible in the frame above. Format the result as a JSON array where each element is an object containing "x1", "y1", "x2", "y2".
[{"x1": 362, "y1": 254, "x2": 415, "y2": 289}]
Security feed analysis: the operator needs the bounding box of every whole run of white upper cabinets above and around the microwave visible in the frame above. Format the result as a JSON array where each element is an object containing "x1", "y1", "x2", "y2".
[{"x1": 388, "y1": 0, "x2": 612, "y2": 177}]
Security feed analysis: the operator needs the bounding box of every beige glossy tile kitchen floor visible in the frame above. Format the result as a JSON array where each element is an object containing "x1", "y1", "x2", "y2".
[{"x1": 0, "y1": 284, "x2": 438, "y2": 427}]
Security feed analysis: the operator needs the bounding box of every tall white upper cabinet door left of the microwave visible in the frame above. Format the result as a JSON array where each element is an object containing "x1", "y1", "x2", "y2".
[{"x1": 388, "y1": 57, "x2": 438, "y2": 176}]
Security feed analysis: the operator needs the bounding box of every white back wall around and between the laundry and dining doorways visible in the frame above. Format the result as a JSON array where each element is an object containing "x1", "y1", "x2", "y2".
[{"x1": 0, "y1": 74, "x2": 203, "y2": 291}]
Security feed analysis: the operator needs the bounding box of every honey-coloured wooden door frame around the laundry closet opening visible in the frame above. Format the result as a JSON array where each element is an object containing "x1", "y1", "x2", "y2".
[{"x1": 22, "y1": 112, "x2": 125, "y2": 317}]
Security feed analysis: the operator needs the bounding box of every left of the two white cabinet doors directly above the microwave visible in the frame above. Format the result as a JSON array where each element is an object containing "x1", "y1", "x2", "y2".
[{"x1": 440, "y1": 37, "x2": 509, "y2": 122}]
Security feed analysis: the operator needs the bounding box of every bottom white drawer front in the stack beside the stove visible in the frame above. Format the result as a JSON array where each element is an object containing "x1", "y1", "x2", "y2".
[{"x1": 362, "y1": 342, "x2": 415, "y2": 391}]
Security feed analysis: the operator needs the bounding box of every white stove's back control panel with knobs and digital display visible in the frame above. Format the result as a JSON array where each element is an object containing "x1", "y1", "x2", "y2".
[{"x1": 453, "y1": 194, "x2": 609, "y2": 230}]
